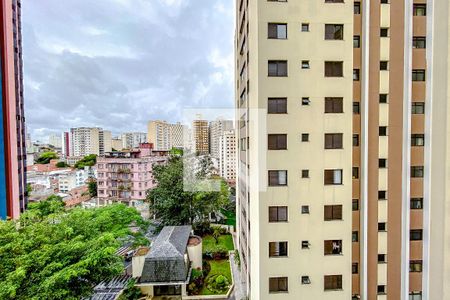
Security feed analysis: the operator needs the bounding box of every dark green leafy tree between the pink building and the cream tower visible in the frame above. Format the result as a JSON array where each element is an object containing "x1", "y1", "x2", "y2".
[{"x1": 147, "y1": 156, "x2": 229, "y2": 226}]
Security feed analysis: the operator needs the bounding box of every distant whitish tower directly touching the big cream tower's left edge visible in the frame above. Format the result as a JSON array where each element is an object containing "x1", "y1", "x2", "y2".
[{"x1": 219, "y1": 130, "x2": 236, "y2": 181}]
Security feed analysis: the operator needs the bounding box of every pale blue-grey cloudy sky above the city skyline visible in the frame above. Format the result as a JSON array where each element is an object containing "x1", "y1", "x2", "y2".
[{"x1": 22, "y1": 0, "x2": 234, "y2": 140}]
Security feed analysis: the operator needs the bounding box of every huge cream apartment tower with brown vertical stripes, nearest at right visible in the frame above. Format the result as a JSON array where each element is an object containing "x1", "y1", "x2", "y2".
[{"x1": 235, "y1": 0, "x2": 450, "y2": 300}]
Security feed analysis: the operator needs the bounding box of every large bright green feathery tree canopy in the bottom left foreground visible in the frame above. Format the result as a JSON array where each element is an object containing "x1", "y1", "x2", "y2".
[{"x1": 0, "y1": 197, "x2": 145, "y2": 300}]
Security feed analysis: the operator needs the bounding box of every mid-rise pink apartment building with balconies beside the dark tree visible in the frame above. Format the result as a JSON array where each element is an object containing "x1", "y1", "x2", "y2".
[{"x1": 96, "y1": 144, "x2": 168, "y2": 205}]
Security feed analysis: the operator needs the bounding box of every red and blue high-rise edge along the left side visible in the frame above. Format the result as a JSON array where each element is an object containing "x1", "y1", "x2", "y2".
[{"x1": 0, "y1": 0, "x2": 27, "y2": 219}]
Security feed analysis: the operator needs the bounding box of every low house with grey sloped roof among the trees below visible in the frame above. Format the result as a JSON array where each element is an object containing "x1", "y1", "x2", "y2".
[{"x1": 133, "y1": 226, "x2": 202, "y2": 297}]
